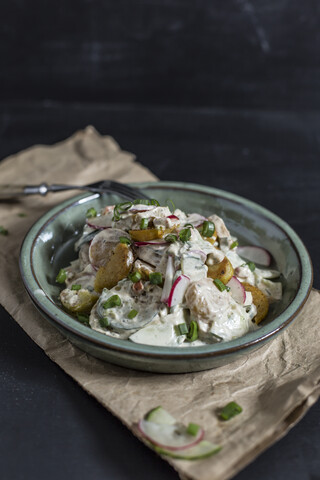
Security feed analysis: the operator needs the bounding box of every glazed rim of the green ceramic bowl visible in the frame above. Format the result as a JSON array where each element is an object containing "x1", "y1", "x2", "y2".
[{"x1": 19, "y1": 181, "x2": 313, "y2": 360}]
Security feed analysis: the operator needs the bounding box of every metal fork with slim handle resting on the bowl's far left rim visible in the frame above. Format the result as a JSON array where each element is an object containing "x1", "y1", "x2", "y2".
[{"x1": 0, "y1": 180, "x2": 149, "y2": 200}]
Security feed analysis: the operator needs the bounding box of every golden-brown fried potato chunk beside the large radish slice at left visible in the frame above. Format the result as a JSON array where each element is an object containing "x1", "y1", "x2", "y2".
[{"x1": 94, "y1": 243, "x2": 134, "y2": 292}]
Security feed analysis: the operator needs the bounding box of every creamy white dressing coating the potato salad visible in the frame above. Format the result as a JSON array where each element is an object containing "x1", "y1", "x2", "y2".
[{"x1": 61, "y1": 204, "x2": 282, "y2": 347}]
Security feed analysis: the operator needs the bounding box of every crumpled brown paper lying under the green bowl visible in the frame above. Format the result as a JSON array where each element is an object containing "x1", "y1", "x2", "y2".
[{"x1": 0, "y1": 127, "x2": 320, "y2": 480}]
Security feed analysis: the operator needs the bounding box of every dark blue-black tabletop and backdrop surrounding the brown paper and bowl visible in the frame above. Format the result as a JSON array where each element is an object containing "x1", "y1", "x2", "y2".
[{"x1": 0, "y1": 0, "x2": 320, "y2": 480}]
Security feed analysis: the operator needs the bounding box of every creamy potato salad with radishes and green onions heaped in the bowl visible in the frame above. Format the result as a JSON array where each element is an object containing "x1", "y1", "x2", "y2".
[{"x1": 57, "y1": 200, "x2": 282, "y2": 347}]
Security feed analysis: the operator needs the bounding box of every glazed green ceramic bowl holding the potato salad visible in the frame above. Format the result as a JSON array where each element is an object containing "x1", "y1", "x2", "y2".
[{"x1": 20, "y1": 182, "x2": 312, "y2": 373}]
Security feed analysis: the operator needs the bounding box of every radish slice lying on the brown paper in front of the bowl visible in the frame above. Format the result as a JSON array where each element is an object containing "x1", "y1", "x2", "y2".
[{"x1": 138, "y1": 419, "x2": 204, "y2": 451}]
